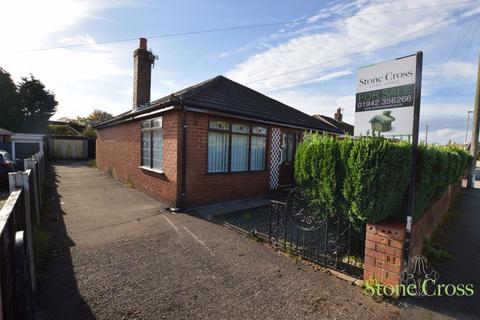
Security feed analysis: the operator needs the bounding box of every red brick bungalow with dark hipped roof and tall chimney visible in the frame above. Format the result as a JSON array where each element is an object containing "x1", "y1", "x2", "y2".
[{"x1": 95, "y1": 38, "x2": 342, "y2": 208}]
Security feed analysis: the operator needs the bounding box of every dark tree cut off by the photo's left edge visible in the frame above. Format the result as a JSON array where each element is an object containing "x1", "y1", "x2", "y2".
[{"x1": 0, "y1": 68, "x2": 22, "y2": 131}]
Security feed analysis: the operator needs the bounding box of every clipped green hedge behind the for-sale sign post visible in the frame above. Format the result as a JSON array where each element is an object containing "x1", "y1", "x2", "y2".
[{"x1": 295, "y1": 133, "x2": 470, "y2": 224}]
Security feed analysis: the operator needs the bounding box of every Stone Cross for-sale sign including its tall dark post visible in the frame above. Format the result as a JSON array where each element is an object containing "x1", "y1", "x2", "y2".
[{"x1": 355, "y1": 51, "x2": 423, "y2": 268}]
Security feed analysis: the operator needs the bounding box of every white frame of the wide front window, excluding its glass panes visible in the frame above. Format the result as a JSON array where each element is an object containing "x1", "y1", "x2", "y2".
[{"x1": 205, "y1": 117, "x2": 270, "y2": 175}]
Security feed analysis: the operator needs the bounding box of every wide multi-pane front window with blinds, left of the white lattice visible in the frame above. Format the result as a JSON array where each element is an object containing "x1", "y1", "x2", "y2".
[{"x1": 207, "y1": 120, "x2": 267, "y2": 173}]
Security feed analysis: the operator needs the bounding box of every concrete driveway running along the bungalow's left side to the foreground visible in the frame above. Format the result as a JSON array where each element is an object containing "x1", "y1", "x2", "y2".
[{"x1": 39, "y1": 163, "x2": 448, "y2": 320}]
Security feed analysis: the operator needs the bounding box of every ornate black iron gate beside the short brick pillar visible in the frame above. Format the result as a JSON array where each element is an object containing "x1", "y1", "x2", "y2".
[{"x1": 268, "y1": 188, "x2": 365, "y2": 278}]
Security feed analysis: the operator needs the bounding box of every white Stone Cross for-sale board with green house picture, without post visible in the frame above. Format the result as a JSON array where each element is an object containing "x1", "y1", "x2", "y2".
[{"x1": 354, "y1": 55, "x2": 417, "y2": 136}]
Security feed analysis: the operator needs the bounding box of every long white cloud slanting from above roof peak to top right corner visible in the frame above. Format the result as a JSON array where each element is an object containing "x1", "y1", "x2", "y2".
[{"x1": 227, "y1": 0, "x2": 474, "y2": 90}]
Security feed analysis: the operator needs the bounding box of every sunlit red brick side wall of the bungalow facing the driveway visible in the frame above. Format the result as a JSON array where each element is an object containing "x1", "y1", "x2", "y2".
[{"x1": 96, "y1": 111, "x2": 181, "y2": 206}]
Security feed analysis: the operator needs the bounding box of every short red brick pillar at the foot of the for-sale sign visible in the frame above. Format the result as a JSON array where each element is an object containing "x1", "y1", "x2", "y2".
[{"x1": 363, "y1": 220, "x2": 405, "y2": 285}]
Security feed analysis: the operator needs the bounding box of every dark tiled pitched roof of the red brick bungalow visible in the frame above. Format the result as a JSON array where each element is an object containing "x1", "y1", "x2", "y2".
[{"x1": 99, "y1": 76, "x2": 342, "y2": 133}]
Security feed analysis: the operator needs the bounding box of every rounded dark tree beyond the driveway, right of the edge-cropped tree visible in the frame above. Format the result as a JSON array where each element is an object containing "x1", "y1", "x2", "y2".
[{"x1": 18, "y1": 75, "x2": 58, "y2": 132}]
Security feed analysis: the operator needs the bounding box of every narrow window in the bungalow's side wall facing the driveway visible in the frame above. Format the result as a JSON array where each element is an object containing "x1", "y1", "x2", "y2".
[{"x1": 141, "y1": 117, "x2": 163, "y2": 171}]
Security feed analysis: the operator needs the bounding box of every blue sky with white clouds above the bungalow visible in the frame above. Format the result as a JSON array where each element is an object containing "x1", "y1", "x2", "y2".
[{"x1": 0, "y1": 0, "x2": 480, "y2": 143}]
